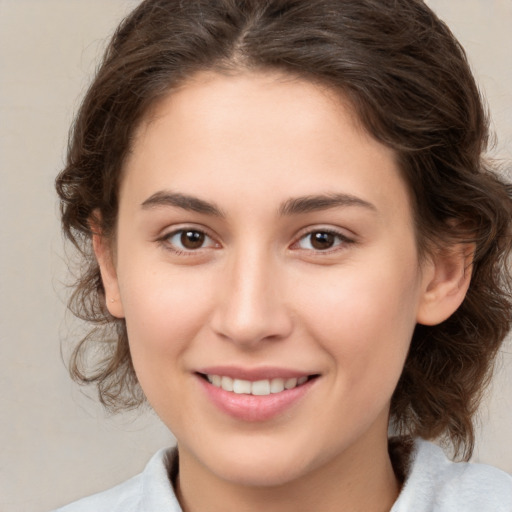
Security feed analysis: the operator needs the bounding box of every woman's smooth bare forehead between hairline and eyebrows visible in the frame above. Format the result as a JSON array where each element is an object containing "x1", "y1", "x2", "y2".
[{"x1": 123, "y1": 72, "x2": 408, "y2": 224}]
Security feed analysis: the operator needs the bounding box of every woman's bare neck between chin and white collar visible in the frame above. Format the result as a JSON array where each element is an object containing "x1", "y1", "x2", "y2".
[{"x1": 176, "y1": 439, "x2": 400, "y2": 512}]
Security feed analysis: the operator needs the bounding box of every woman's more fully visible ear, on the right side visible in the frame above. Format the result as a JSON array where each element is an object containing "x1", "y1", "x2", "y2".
[{"x1": 416, "y1": 243, "x2": 475, "y2": 325}]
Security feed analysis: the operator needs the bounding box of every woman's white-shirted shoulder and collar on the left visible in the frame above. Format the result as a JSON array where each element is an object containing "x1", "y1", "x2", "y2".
[{"x1": 55, "y1": 449, "x2": 181, "y2": 512}]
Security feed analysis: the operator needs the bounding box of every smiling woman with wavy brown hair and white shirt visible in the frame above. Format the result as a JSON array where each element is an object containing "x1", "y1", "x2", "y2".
[{"x1": 53, "y1": 0, "x2": 512, "y2": 512}]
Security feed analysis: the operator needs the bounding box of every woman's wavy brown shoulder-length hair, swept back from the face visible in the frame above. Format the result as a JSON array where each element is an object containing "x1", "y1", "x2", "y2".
[{"x1": 57, "y1": 0, "x2": 512, "y2": 457}]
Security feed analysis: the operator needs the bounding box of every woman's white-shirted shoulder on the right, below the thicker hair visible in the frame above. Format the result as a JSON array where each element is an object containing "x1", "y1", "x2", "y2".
[{"x1": 392, "y1": 440, "x2": 512, "y2": 512}]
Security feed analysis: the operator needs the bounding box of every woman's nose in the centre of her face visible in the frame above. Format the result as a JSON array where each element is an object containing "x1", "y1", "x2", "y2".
[{"x1": 212, "y1": 247, "x2": 293, "y2": 349}]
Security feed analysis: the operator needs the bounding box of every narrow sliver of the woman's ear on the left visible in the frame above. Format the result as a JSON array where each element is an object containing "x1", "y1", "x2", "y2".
[{"x1": 92, "y1": 224, "x2": 124, "y2": 318}]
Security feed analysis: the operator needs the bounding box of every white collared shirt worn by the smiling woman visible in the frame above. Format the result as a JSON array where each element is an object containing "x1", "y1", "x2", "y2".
[{"x1": 55, "y1": 440, "x2": 512, "y2": 512}]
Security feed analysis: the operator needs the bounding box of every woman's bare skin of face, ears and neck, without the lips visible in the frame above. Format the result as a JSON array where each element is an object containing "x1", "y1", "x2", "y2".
[{"x1": 94, "y1": 72, "x2": 469, "y2": 512}]
